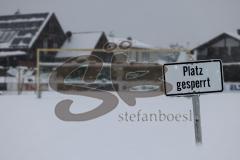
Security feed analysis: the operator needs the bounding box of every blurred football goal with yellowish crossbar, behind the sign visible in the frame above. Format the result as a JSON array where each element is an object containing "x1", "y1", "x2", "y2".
[{"x1": 36, "y1": 45, "x2": 190, "y2": 98}]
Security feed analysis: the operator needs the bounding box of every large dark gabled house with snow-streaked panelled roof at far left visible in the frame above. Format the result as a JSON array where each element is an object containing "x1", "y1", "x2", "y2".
[{"x1": 0, "y1": 13, "x2": 66, "y2": 67}]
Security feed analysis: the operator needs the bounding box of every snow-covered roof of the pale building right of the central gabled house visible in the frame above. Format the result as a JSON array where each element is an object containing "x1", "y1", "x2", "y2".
[{"x1": 107, "y1": 36, "x2": 153, "y2": 48}]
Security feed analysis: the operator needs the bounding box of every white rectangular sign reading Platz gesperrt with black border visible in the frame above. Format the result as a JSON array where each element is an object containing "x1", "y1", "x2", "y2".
[{"x1": 163, "y1": 60, "x2": 223, "y2": 96}]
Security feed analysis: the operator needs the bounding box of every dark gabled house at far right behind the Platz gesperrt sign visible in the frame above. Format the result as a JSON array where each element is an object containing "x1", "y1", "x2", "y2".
[{"x1": 191, "y1": 30, "x2": 240, "y2": 82}]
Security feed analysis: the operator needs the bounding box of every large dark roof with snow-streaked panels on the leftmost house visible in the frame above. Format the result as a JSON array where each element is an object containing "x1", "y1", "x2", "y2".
[{"x1": 0, "y1": 13, "x2": 52, "y2": 49}]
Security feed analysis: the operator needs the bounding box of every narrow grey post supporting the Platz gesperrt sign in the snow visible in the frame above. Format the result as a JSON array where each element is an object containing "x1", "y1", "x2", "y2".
[{"x1": 192, "y1": 95, "x2": 202, "y2": 144}]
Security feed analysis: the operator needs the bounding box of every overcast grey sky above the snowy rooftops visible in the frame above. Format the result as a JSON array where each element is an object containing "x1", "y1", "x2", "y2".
[{"x1": 0, "y1": 0, "x2": 240, "y2": 47}]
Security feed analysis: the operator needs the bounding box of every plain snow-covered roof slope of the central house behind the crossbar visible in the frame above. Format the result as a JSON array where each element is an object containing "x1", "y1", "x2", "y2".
[{"x1": 56, "y1": 32, "x2": 103, "y2": 58}]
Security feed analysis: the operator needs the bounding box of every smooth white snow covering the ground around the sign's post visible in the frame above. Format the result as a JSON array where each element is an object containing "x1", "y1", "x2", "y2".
[{"x1": 0, "y1": 92, "x2": 240, "y2": 160}]
